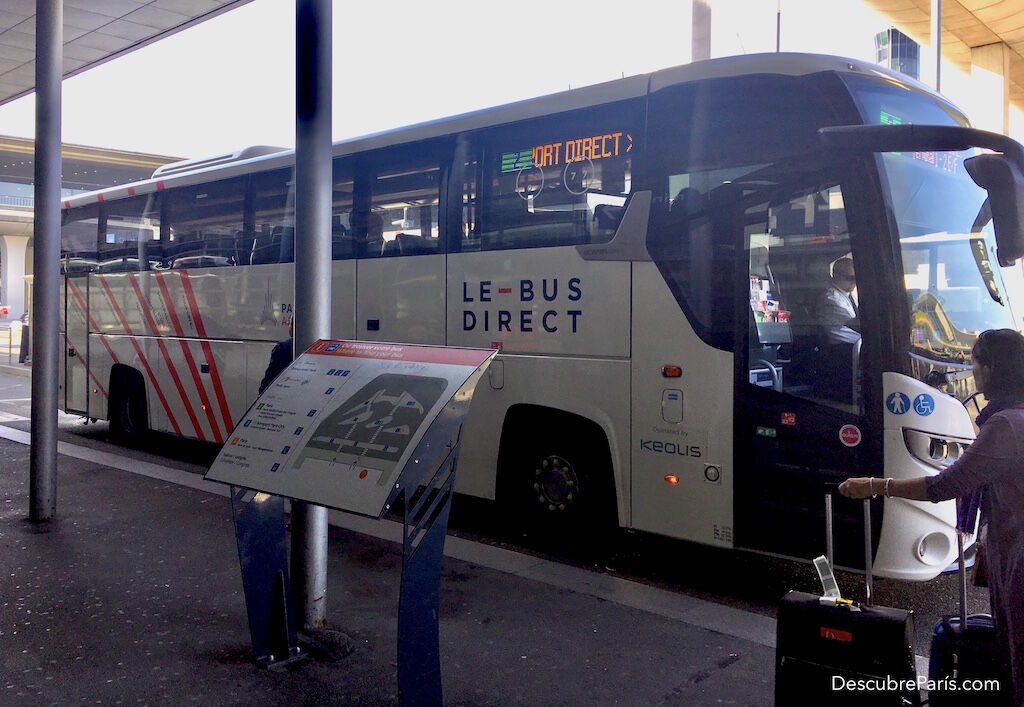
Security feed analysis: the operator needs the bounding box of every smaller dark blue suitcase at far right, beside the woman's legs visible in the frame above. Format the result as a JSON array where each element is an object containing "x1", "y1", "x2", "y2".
[{"x1": 928, "y1": 532, "x2": 1013, "y2": 707}]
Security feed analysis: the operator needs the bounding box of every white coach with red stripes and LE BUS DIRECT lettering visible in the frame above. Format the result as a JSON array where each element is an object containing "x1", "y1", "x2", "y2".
[{"x1": 60, "y1": 53, "x2": 1024, "y2": 580}]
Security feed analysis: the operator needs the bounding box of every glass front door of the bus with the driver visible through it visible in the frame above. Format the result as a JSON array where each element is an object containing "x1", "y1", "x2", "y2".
[{"x1": 734, "y1": 164, "x2": 880, "y2": 566}]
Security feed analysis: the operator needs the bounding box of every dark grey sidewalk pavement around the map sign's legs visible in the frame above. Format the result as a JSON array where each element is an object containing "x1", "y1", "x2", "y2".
[{"x1": 0, "y1": 427, "x2": 774, "y2": 705}]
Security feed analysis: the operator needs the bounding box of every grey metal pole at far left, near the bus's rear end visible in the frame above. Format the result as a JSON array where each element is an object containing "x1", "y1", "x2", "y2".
[{"x1": 29, "y1": 0, "x2": 63, "y2": 523}]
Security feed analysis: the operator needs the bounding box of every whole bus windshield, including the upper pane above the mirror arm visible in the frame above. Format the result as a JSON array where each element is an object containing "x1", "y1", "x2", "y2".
[{"x1": 846, "y1": 76, "x2": 1013, "y2": 368}]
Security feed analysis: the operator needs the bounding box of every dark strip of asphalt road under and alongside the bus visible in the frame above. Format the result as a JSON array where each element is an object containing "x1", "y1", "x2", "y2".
[{"x1": 0, "y1": 372, "x2": 988, "y2": 656}]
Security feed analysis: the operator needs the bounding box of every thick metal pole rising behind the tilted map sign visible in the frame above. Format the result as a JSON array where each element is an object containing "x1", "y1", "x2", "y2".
[{"x1": 291, "y1": 0, "x2": 333, "y2": 628}]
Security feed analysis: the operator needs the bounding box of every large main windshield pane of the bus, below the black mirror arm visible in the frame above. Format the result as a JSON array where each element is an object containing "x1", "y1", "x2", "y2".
[{"x1": 882, "y1": 152, "x2": 1013, "y2": 365}]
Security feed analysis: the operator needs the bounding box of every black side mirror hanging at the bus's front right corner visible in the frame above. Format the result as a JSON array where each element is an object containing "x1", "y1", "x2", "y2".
[{"x1": 964, "y1": 154, "x2": 1024, "y2": 267}]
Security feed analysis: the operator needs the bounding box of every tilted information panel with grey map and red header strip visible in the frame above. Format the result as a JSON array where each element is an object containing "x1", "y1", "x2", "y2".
[{"x1": 206, "y1": 340, "x2": 496, "y2": 516}]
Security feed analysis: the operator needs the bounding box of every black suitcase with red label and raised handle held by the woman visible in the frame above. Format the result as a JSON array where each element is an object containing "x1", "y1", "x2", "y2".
[{"x1": 775, "y1": 497, "x2": 921, "y2": 707}]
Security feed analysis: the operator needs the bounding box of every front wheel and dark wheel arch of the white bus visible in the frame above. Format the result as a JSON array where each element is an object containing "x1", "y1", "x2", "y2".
[{"x1": 496, "y1": 405, "x2": 617, "y2": 545}]
